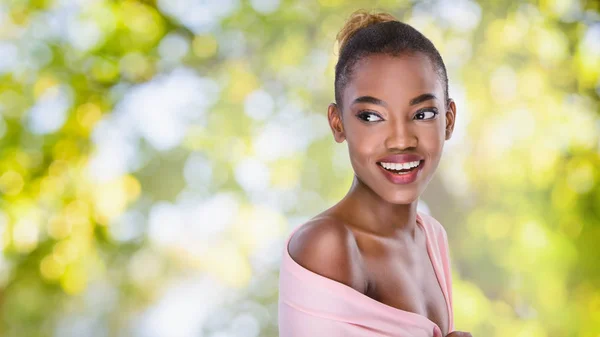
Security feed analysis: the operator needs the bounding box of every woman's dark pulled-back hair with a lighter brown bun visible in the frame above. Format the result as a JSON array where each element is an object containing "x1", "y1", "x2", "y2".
[{"x1": 335, "y1": 10, "x2": 448, "y2": 109}]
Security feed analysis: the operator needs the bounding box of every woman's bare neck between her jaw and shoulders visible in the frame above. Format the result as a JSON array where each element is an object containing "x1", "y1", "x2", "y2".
[{"x1": 338, "y1": 176, "x2": 418, "y2": 238}]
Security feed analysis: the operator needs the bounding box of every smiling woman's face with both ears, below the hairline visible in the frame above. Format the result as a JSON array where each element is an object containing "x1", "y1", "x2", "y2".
[{"x1": 328, "y1": 53, "x2": 456, "y2": 204}]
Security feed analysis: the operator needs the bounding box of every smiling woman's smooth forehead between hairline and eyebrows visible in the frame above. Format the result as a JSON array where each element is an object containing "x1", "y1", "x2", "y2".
[{"x1": 344, "y1": 53, "x2": 443, "y2": 103}]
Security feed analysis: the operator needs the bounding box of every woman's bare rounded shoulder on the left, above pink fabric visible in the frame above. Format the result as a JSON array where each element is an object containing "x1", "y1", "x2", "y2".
[{"x1": 288, "y1": 216, "x2": 367, "y2": 293}]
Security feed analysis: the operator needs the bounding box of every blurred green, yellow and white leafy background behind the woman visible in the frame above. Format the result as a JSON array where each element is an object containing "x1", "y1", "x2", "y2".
[{"x1": 0, "y1": 0, "x2": 600, "y2": 337}]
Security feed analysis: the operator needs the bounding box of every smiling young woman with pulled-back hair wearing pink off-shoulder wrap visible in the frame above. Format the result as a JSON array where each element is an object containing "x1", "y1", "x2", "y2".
[{"x1": 279, "y1": 11, "x2": 470, "y2": 337}]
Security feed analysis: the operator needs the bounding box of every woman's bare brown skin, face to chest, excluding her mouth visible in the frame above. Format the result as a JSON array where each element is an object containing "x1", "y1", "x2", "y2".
[{"x1": 288, "y1": 53, "x2": 470, "y2": 337}]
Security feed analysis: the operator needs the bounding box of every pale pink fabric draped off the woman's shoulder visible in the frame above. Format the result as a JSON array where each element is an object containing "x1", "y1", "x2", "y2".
[{"x1": 278, "y1": 213, "x2": 454, "y2": 337}]
